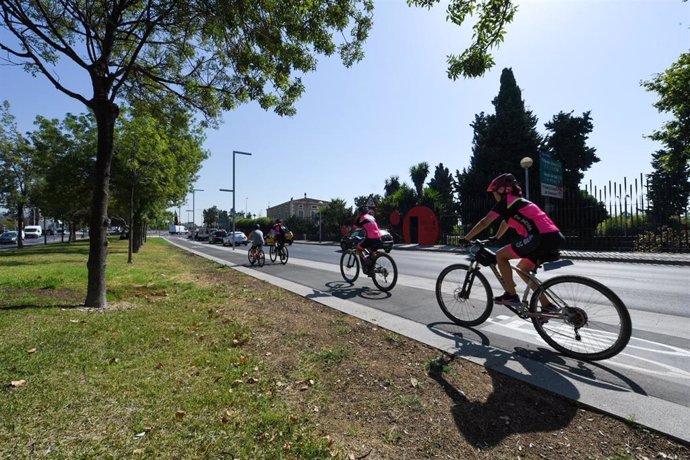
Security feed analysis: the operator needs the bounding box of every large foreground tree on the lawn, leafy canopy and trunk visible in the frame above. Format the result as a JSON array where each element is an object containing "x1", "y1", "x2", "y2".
[{"x1": 0, "y1": 0, "x2": 373, "y2": 307}]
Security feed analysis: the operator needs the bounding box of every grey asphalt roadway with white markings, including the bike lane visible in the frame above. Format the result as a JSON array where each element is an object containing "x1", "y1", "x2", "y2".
[{"x1": 171, "y1": 238, "x2": 690, "y2": 441}]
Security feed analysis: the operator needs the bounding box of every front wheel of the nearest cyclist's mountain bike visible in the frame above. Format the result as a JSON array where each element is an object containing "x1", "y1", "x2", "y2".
[{"x1": 436, "y1": 264, "x2": 494, "y2": 327}]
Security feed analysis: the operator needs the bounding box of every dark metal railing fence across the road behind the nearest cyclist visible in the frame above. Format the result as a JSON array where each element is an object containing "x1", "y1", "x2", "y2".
[{"x1": 441, "y1": 175, "x2": 690, "y2": 252}]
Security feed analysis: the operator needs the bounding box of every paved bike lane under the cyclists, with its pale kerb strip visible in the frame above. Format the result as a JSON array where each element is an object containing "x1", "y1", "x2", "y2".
[{"x1": 168, "y1": 239, "x2": 690, "y2": 442}]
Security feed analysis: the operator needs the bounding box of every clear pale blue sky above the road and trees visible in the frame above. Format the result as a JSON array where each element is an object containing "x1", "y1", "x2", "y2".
[{"x1": 0, "y1": 0, "x2": 690, "y2": 223}]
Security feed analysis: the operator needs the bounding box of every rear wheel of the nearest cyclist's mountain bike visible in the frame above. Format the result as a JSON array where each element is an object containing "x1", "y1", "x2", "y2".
[{"x1": 530, "y1": 276, "x2": 632, "y2": 361}]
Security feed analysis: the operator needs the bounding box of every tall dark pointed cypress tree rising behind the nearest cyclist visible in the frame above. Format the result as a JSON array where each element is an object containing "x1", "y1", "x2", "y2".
[{"x1": 456, "y1": 68, "x2": 542, "y2": 226}]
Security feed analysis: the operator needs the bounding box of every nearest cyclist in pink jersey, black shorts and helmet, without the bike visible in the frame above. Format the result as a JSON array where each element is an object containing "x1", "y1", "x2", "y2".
[{"x1": 464, "y1": 173, "x2": 565, "y2": 313}]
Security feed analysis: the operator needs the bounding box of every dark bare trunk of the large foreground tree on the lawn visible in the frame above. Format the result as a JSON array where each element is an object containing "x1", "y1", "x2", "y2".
[{"x1": 84, "y1": 97, "x2": 118, "y2": 308}]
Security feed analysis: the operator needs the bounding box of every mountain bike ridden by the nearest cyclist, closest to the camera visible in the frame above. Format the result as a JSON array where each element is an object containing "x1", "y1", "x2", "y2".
[{"x1": 436, "y1": 240, "x2": 632, "y2": 361}]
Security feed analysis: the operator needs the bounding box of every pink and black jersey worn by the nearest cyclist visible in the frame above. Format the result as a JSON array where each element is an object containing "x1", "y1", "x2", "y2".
[{"x1": 489, "y1": 195, "x2": 559, "y2": 236}]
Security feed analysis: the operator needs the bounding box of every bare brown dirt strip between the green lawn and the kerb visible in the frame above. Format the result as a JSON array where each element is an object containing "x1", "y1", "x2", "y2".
[{"x1": 197, "y1": 262, "x2": 690, "y2": 459}]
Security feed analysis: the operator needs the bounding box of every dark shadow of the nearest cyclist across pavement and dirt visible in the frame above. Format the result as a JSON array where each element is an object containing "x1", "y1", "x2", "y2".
[{"x1": 422, "y1": 330, "x2": 579, "y2": 448}]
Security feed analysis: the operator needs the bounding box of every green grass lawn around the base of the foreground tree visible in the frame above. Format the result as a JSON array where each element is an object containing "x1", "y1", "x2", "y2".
[{"x1": 0, "y1": 238, "x2": 335, "y2": 459}]
